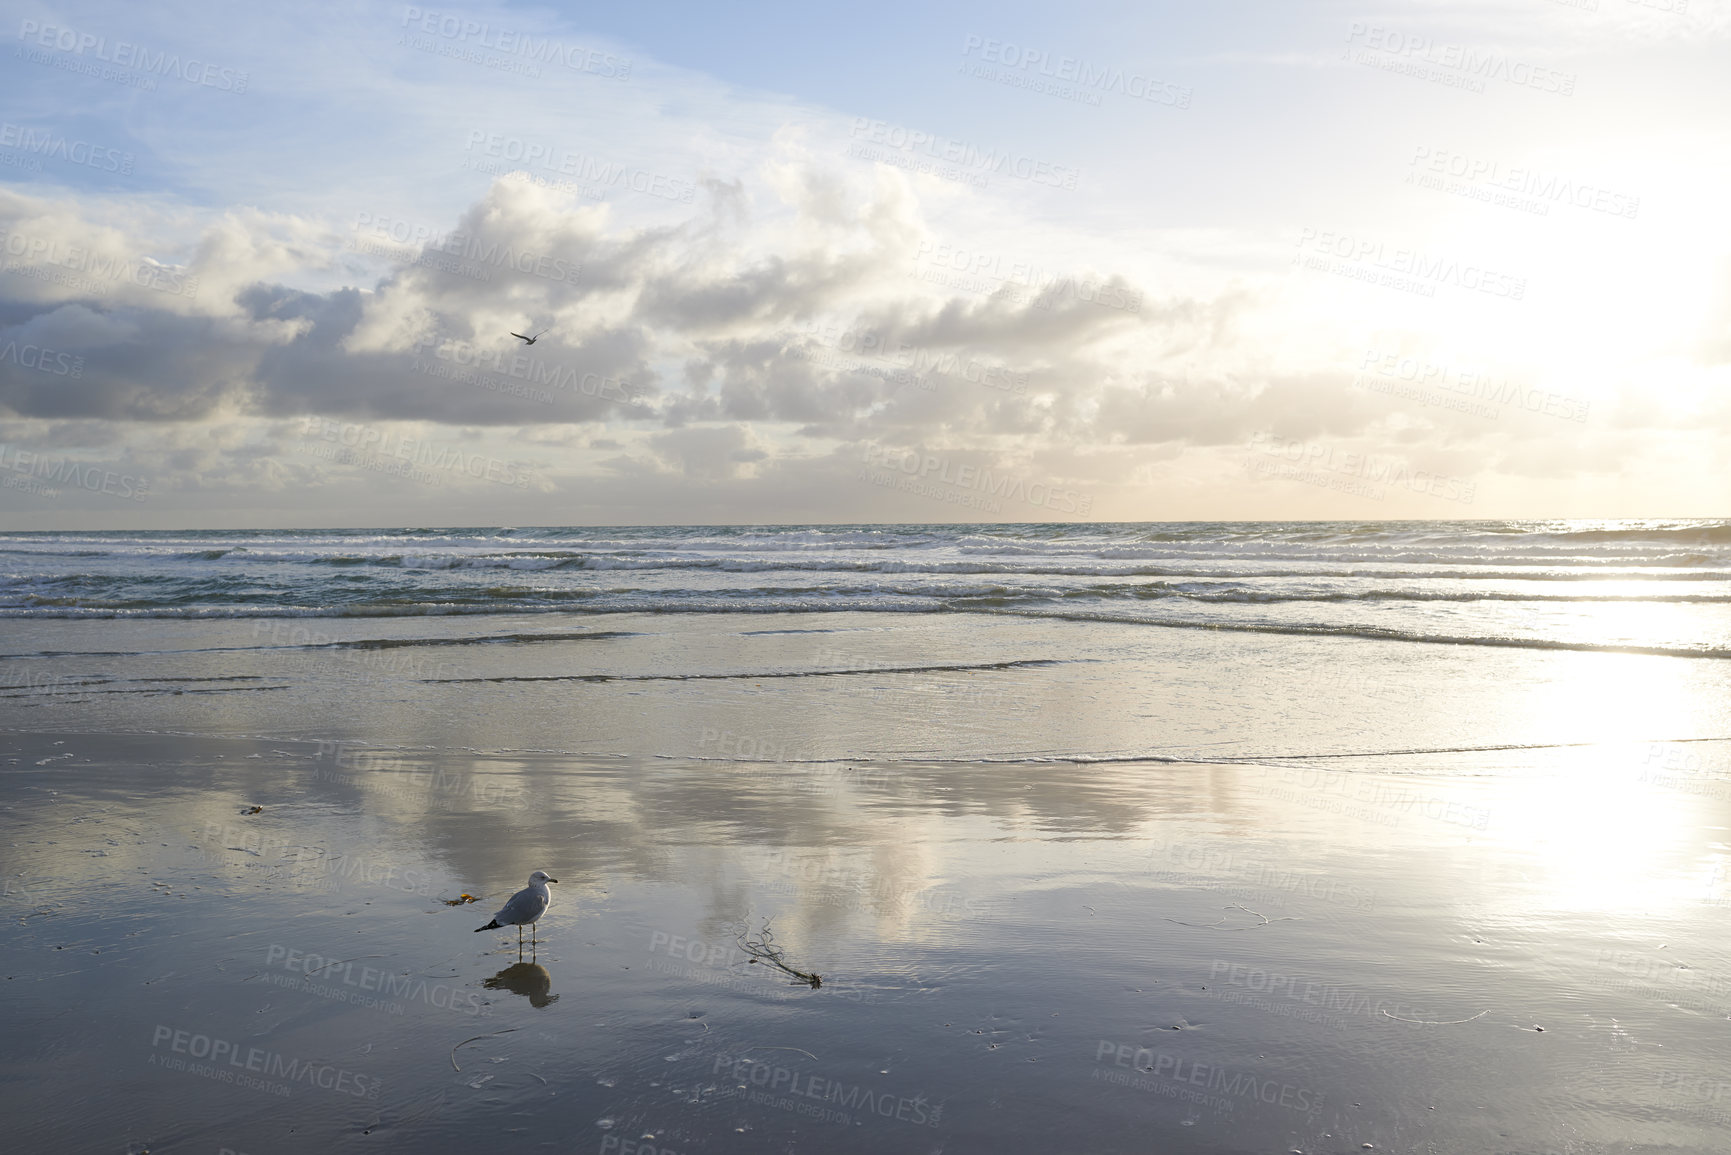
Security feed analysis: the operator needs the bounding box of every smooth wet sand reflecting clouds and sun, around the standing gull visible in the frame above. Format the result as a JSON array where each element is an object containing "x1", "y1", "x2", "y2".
[{"x1": 0, "y1": 727, "x2": 1731, "y2": 1155}]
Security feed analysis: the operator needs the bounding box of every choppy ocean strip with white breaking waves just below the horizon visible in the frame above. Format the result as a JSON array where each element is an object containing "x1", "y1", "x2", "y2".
[{"x1": 0, "y1": 521, "x2": 1731, "y2": 658}]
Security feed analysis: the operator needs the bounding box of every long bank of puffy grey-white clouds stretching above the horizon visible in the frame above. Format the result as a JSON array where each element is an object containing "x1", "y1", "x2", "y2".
[{"x1": 0, "y1": 98, "x2": 1717, "y2": 519}]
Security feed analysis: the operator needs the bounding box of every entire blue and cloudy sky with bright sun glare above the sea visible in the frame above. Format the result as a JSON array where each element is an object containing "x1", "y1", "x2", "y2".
[{"x1": 0, "y1": 0, "x2": 1731, "y2": 530}]
